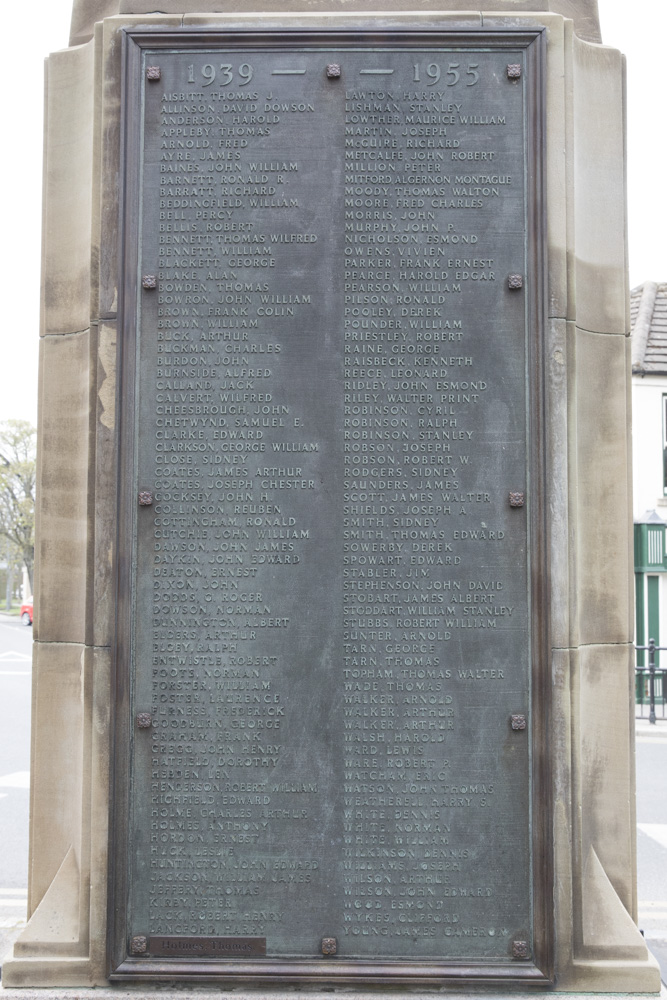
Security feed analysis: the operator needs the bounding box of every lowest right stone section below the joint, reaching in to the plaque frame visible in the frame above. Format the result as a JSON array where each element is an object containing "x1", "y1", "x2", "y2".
[{"x1": 551, "y1": 644, "x2": 660, "y2": 993}]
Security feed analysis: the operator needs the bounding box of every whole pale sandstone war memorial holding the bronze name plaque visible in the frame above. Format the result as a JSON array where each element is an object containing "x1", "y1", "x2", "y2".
[{"x1": 3, "y1": 0, "x2": 659, "y2": 992}]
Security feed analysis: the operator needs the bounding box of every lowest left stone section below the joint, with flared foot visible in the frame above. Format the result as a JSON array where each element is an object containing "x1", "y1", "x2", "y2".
[{"x1": 2, "y1": 642, "x2": 110, "y2": 992}]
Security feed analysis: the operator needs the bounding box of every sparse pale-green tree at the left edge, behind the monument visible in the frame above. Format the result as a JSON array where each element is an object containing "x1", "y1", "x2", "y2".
[{"x1": 0, "y1": 420, "x2": 37, "y2": 591}]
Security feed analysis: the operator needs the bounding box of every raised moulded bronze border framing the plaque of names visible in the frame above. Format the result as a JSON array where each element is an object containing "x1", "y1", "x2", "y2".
[{"x1": 107, "y1": 16, "x2": 554, "y2": 989}]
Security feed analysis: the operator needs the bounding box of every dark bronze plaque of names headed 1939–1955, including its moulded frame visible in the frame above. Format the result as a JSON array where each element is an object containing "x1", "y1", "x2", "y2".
[{"x1": 112, "y1": 20, "x2": 549, "y2": 983}]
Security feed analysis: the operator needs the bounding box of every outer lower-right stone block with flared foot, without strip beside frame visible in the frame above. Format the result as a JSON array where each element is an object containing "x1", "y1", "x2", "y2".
[{"x1": 563, "y1": 643, "x2": 660, "y2": 992}]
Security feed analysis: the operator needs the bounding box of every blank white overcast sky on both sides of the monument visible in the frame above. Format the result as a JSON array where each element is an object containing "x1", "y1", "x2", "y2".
[{"x1": 0, "y1": 0, "x2": 667, "y2": 423}]
